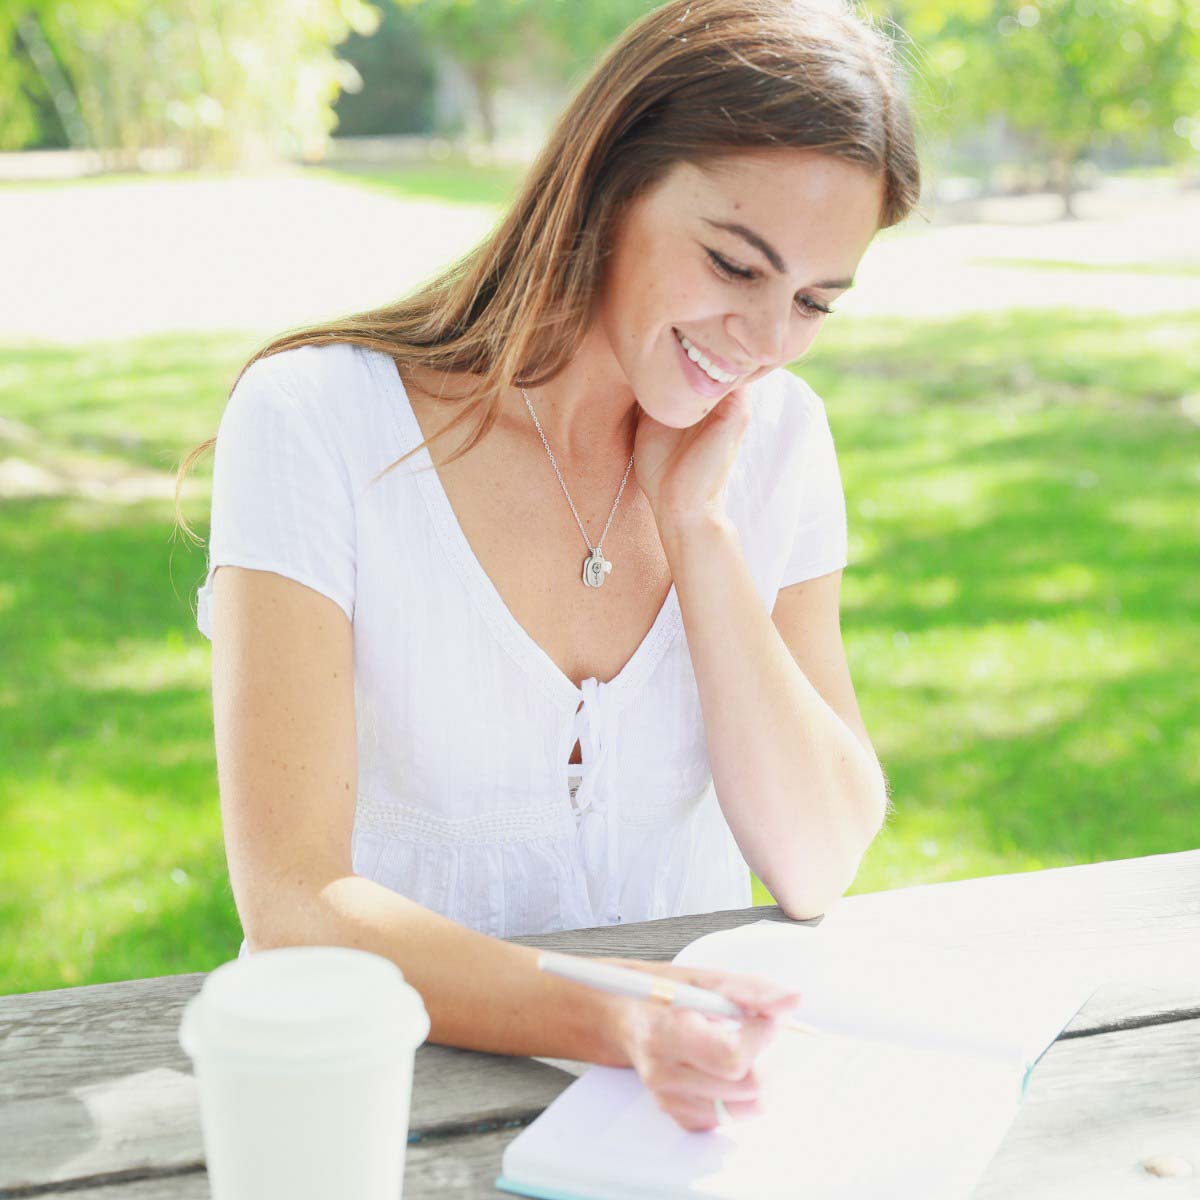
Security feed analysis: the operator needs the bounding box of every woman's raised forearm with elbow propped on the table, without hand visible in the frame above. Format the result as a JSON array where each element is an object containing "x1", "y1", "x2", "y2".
[{"x1": 659, "y1": 510, "x2": 887, "y2": 919}]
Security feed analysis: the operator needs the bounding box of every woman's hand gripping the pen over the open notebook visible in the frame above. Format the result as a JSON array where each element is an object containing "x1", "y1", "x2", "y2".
[{"x1": 601, "y1": 958, "x2": 800, "y2": 1132}]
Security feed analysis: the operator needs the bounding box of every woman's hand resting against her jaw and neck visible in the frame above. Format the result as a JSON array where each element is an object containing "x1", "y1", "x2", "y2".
[{"x1": 634, "y1": 386, "x2": 750, "y2": 532}]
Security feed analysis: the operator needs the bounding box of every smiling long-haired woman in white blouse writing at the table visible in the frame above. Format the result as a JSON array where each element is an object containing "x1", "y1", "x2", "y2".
[{"x1": 174, "y1": 0, "x2": 919, "y2": 1129}]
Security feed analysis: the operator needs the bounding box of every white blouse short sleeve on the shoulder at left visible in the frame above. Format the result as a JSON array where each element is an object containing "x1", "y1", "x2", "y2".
[{"x1": 196, "y1": 352, "x2": 355, "y2": 640}]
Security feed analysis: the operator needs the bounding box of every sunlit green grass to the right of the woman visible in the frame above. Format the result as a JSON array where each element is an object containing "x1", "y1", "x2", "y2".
[{"x1": 760, "y1": 312, "x2": 1200, "y2": 900}]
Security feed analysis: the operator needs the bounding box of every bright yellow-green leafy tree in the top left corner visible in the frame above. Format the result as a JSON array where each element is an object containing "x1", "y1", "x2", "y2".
[{"x1": 0, "y1": 0, "x2": 379, "y2": 168}]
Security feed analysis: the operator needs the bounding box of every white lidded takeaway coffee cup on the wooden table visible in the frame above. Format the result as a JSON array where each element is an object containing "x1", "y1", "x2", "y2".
[{"x1": 179, "y1": 946, "x2": 430, "y2": 1200}]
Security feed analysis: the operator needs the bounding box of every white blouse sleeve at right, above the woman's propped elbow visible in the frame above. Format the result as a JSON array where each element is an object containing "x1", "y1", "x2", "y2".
[{"x1": 779, "y1": 376, "x2": 848, "y2": 588}]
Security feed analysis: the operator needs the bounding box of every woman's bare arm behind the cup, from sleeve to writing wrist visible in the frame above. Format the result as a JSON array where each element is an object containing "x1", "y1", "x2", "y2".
[{"x1": 212, "y1": 566, "x2": 630, "y2": 1066}]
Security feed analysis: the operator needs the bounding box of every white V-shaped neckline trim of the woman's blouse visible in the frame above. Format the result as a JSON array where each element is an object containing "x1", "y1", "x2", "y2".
[{"x1": 368, "y1": 350, "x2": 683, "y2": 712}]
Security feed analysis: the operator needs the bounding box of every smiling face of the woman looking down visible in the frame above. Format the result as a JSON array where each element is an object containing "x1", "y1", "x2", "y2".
[{"x1": 598, "y1": 149, "x2": 883, "y2": 428}]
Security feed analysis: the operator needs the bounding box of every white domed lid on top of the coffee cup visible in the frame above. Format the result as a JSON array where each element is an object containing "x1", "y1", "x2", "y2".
[{"x1": 179, "y1": 946, "x2": 430, "y2": 1064}]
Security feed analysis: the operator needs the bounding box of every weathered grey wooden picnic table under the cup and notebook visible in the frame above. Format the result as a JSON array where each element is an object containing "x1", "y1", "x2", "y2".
[{"x1": 0, "y1": 850, "x2": 1200, "y2": 1200}]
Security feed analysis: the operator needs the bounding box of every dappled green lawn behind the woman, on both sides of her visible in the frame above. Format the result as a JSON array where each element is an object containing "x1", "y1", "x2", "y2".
[{"x1": 0, "y1": 312, "x2": 1200, "y2": 992}]
